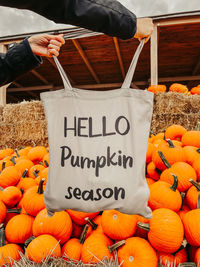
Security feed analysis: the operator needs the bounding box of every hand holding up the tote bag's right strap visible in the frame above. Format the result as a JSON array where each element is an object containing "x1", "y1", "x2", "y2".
[{"x1": 134, "y1": 18, "x2": 154, "y2": 42}]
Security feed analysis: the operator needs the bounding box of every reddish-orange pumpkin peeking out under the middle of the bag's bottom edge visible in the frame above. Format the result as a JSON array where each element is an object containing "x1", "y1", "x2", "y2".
[{"x1": 67, "y1": 209, "x2": 99, "y2": 225}]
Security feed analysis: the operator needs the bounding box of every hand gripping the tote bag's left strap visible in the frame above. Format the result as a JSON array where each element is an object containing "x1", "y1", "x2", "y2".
[{"x1": 28, "y1": 34, "x2": 65, "y2": 57}]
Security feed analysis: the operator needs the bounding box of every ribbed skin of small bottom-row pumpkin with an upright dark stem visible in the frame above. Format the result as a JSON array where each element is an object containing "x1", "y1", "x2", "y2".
[{"x1": 62, "y1": 238, "x2": 83, "y2": 261}]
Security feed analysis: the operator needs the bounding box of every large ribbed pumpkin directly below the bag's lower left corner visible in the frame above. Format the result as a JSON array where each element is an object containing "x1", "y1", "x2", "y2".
[{"x1": 33, "y1": 209, "x2": 72, "y2": 244}]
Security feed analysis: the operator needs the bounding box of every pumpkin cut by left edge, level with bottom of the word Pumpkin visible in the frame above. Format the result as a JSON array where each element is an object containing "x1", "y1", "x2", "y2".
[{"x1": 0, "y1": 166, "x2": 22, "y2": 188}]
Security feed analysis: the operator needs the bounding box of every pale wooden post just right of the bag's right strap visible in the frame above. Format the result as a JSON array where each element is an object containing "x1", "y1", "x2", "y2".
[{"x1": 151, "y1": 25, "x2": 158, "y2": 85}]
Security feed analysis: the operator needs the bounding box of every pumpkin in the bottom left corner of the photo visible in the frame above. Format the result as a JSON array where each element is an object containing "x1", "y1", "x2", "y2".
[{"x1": 0, "y1": 224, "x2": 23, "y2": 266}]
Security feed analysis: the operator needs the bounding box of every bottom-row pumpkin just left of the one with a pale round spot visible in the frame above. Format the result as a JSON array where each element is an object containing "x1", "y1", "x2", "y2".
[{"x1": 81, "y1": 232, "x2": 113, "y2": 263}]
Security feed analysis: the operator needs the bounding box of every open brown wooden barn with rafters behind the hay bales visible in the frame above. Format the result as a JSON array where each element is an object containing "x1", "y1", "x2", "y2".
[{"x1": 0, "y1": 12, "x2": 200, "y2": 105}]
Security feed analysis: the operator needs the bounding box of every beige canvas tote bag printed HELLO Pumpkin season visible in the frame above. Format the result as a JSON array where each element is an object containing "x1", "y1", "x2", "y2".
[{"x1": 41, "y1": 42, "x2": 153, "y2": 218}]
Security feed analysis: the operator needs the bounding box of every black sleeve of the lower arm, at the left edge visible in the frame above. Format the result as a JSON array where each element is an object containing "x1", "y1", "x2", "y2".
[{"x1": 0, "y1": 39, "x2": 42, "y2": 86}]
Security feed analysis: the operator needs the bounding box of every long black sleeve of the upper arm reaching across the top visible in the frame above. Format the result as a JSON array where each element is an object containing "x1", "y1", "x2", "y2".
[{"x1": 0, "y1": 0, "x2": 137, "y2": 39}]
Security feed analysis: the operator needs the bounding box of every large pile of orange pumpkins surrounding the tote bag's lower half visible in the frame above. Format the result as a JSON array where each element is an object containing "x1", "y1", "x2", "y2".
[{"x1": 0, "y1": 125, "x2": 200, "y2": 267}]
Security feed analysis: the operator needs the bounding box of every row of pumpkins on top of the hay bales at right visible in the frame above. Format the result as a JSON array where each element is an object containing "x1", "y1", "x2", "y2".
[{"x1": 147, "y1": 83, "x2": 200, "y2": 95}]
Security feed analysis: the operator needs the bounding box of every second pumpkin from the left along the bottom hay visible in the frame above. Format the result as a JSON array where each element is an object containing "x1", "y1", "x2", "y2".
[{"x1": 25, "y1": 235, "x2": 61, "y2": 263}]
